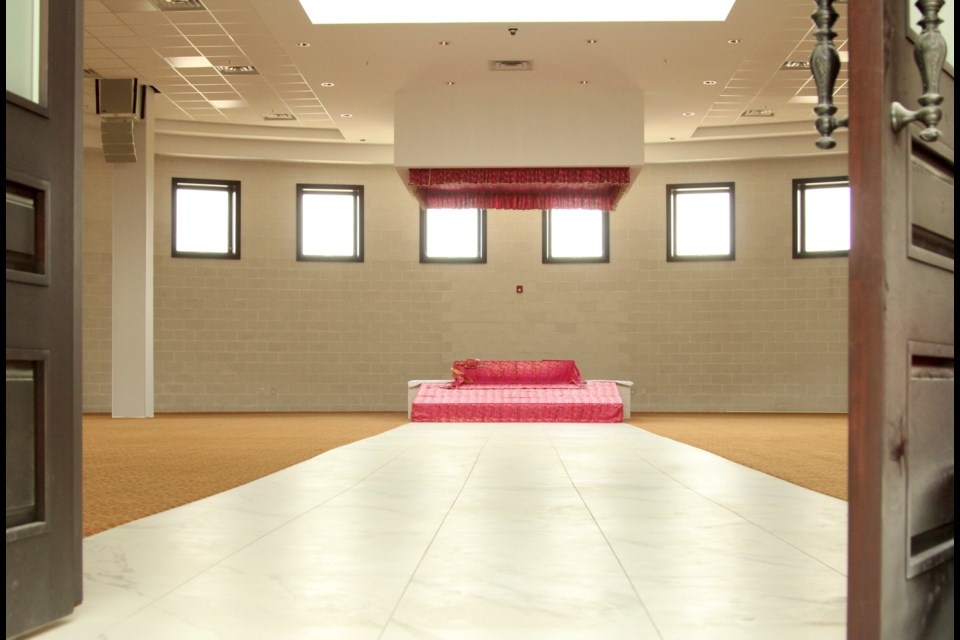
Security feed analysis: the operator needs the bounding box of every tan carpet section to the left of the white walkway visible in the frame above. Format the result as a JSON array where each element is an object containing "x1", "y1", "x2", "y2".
[{"x1": 83, "y1": 412, "x2": 407, "y2": 536}]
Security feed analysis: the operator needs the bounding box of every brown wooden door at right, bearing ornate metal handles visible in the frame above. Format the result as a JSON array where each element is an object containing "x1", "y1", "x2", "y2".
[{"x1": 846, "y1": 0, "x2": 954, "y2": 640}]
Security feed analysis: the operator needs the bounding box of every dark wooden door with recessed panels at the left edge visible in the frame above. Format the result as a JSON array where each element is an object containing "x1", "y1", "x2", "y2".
[{"x1": 6, "y1": 0, "x2": 82, "y2": 637}]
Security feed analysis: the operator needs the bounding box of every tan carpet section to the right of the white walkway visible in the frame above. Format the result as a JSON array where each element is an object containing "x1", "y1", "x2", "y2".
[{"x1": 629, "y1": 413, "x2": 848, "y2": 500}]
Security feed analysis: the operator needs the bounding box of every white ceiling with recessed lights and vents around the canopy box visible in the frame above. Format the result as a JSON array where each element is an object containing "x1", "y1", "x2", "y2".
[{"x1": 83, "y1": 0, "x2": 847, "y2": 158}]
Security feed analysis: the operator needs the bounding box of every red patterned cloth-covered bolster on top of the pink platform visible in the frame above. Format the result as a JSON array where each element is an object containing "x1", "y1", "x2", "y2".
[{"x1": 450, "y1": 360, "x2": 583, "y2": 387}]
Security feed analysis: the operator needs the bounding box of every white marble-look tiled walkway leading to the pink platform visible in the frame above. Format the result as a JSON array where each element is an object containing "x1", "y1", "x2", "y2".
[{"x1": 28, "y1": 423, "x2": 846, "y2": 640}]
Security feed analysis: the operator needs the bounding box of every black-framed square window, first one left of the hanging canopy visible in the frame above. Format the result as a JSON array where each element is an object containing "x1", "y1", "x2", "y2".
[{"x1": 297, "y1": 184, "x2": 363, "y2": 262}]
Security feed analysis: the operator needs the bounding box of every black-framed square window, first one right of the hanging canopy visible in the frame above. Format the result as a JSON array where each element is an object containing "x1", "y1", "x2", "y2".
[{"x1": 667, "y1": 182, "x2": 736, "y2": 262}]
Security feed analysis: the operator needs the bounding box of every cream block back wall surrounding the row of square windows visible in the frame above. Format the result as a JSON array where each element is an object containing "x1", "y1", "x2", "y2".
[{"x1": 84, "y1": 150, "x2": 847, "y2": 412}]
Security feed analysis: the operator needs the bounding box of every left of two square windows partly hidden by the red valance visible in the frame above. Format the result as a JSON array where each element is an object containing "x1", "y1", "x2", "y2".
[{"x1": 420, "y1": 209, "x2": 487, "y2": 262}]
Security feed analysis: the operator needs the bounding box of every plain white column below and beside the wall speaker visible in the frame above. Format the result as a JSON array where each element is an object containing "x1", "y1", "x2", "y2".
[{"x1": 112, "y1": 87, "x2": 154, "y2": 418}]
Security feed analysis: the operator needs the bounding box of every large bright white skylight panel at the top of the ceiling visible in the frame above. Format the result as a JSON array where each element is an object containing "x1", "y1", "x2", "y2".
[{"x1": 300, "y1": 0, "x2": 734, "y2": 24}]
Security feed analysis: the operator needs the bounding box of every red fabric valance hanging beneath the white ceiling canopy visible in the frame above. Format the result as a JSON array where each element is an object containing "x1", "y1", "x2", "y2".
[{"x1": 408, "y1": 167, "x2": 630, "y2": 211}]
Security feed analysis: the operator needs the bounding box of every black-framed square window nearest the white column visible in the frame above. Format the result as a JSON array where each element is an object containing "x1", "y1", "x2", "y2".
[{"x1": 171, "y1": 178, "x2": 240, "y2": 260}]
